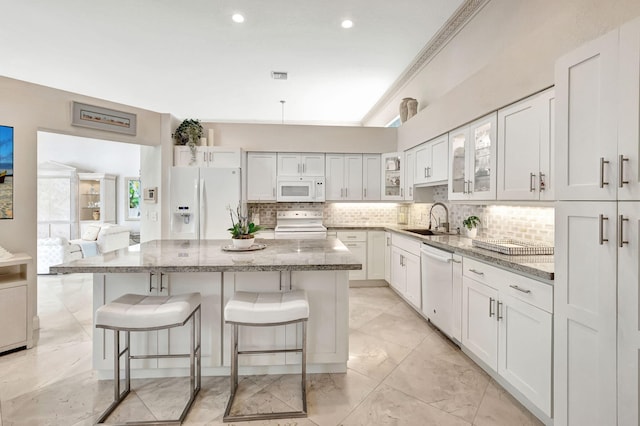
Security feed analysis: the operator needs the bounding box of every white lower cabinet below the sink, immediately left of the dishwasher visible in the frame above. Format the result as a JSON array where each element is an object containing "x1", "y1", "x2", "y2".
[{"x1": 390, "y1": 234, "x2": 422, "y2": 310}]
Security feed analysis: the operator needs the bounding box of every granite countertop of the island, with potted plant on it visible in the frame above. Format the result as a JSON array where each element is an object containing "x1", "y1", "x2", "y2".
[{"x1": 51, "y1": 238, "x2": 362, "y2": 273}]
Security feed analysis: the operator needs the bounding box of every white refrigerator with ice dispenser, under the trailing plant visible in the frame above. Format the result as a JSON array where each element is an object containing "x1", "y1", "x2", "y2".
[{"x1": 169, "y1": 167, "x2": 241, "y2": 240}]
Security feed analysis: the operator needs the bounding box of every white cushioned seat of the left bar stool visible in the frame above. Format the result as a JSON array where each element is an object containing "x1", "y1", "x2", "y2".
[{"x1": 95, "y1": 293, "x2": 200, "y2": 330}]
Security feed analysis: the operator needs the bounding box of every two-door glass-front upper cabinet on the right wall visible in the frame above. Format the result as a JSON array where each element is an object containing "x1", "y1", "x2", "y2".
[{"x1": 449, "y1": 113, "x2": 497, "y2": 200}]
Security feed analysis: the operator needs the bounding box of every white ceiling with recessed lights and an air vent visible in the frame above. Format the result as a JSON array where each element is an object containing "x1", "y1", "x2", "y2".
[{"x1": 0, "y1": 0, "x2": 463, "y2": 125}]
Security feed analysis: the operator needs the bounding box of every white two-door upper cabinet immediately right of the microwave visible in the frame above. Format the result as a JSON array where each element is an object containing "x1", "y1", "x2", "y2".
[{"x1": 325, "y1": 154, "x2": 363, "y2": 201}]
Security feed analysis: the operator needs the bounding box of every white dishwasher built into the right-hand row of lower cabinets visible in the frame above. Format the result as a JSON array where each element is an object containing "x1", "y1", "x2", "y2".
[{"x1": 420, "y1": 244, "x2": 453, "y2": 337}]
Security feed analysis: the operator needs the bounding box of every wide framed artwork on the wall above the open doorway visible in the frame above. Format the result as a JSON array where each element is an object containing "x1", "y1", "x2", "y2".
[{"x1": 71, "y1": 101, "x2": 136, "y2": 135}]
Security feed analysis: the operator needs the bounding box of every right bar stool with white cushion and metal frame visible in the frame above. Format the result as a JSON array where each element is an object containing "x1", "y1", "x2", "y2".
[{"x1": 222, "y1": 290, "x2": 309, "y2": 422}]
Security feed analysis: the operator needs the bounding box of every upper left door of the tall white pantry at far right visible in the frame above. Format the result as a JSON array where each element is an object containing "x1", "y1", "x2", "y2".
[{"x1": 555, "y1": 31, "x2": 620, "y2": 200}]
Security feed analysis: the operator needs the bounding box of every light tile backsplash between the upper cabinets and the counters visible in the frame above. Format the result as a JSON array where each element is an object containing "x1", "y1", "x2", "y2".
[{"x1": 248, "y1": 186, "x2": 554, "y2": 245}]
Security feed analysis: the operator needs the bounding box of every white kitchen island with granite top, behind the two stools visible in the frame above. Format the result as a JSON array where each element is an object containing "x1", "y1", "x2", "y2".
[{"x1": 51, "y1": 238, "x2": 362, "y2": 378}]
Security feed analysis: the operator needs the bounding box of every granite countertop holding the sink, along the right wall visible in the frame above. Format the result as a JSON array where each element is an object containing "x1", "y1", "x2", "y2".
[{"x1": 385, "y1": 226, "x2": 554, "y2": 281}]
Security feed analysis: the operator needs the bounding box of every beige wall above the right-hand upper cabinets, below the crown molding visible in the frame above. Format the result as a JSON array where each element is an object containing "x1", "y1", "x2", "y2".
[{"x1": 365, "y1": 0, "x2": 640, "y2": 150}]
